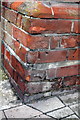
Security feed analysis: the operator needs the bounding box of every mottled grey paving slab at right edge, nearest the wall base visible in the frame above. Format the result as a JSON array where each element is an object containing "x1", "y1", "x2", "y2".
[{"x1": 59, "y1": 92, "x2": 79, "y2": 105}]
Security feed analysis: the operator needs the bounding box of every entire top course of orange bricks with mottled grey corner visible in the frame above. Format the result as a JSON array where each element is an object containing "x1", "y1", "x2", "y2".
[{"x1": 2, "y1": 0, "x2": 80, "y2": 19}]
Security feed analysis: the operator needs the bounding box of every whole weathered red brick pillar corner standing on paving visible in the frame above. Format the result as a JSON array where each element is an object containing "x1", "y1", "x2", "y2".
[{"x1": 1, "y1": 0, "x2": 80, "y2": 101}]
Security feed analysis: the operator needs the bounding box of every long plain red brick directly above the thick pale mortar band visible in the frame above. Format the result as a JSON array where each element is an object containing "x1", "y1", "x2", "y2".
[{"x1": 37, "y1": 50, "x2": 67, "y2": 63}]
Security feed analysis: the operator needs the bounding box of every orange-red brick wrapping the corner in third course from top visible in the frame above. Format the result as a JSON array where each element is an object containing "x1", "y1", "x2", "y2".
[{"x1": 13, "y1": 27, "x2": 50, "y2": 49}]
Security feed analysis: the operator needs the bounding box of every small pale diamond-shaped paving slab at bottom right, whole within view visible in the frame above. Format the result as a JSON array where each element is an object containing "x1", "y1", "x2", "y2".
[{"x1": 47, "y1": 107, "x2": 73, "y2": 119}]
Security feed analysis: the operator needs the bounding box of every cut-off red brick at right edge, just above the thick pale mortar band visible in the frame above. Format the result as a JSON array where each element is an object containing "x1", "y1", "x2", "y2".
[{"x1": 68, "y1": 48, "x2": 80, "y2": 60}]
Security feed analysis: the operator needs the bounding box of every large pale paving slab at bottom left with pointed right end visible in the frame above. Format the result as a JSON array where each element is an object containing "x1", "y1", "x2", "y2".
[{"x1": 4, "y1": 105, "x2": 42, "y2": 118}]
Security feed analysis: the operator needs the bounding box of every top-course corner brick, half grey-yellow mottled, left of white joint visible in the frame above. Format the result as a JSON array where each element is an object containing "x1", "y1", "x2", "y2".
[{"x1": 18, "y1": 0, "x2": 53, "y2": 18}]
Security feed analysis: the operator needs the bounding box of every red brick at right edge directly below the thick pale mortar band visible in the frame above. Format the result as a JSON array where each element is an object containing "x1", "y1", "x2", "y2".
[{"x1": 56, "y1": 65, "x2": 79, "y2": 77}]
